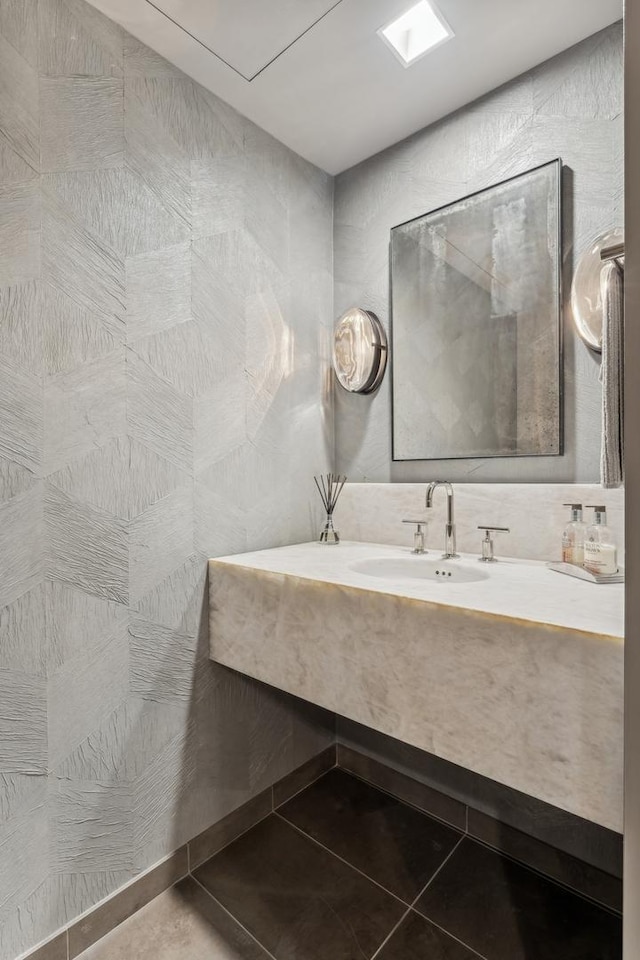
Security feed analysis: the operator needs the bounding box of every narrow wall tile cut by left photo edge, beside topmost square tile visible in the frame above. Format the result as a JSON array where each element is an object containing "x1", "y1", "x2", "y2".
[{"x1": 0, "y1": 33, "x2": 40, "y2": 170}]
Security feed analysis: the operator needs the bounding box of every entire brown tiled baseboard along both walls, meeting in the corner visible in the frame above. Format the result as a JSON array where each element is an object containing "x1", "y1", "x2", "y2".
[{"x1": 18, "y1": 743, "x2": 622, "y2": 960}]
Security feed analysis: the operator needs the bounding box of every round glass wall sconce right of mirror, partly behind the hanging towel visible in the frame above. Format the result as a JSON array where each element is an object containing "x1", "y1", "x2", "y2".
[{"x1": 571, "y1": 227, "x2": 624, "y2": 353}]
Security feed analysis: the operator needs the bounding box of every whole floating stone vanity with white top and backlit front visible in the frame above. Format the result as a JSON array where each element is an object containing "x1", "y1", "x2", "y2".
[{"x1": 209, "y1": 542, "x2": 624, "y2": 831}]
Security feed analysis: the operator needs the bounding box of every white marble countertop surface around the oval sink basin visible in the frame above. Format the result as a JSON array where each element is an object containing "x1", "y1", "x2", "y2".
[{"x1": 211, "y1": 541, "x2": 624, "y2": 638}]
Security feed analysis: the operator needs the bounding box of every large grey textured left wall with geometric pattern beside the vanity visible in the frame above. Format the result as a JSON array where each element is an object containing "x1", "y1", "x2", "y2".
[{"x1": 0, "y1": 0, "x2": 333, "y2": 960}]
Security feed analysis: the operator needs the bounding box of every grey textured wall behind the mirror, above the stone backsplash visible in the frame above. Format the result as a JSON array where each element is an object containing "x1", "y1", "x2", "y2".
[{"x1": 334, "y1": 24, "x2": 623, "y2": 482}]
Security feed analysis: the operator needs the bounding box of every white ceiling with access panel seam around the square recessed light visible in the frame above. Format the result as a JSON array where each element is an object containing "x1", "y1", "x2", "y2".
[{"x1": 91, "y1": 0, "x2": 622, "y2": 173}]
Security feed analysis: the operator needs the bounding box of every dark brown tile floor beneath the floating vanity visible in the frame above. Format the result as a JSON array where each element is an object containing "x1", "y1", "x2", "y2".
[{"x1": 77, "y1": 769, "x2": 622, "y2": 960}]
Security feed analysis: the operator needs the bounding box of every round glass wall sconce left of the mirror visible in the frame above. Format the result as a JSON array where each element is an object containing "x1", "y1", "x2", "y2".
[{"x1": 333, "y1": 307, "x2": 388, "y2": 393}]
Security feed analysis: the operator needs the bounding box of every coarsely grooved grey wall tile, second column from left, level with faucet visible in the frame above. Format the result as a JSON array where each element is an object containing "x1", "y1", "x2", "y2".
[{"x1": 44, "y1": 486, "x2": 129, "y2": 603}]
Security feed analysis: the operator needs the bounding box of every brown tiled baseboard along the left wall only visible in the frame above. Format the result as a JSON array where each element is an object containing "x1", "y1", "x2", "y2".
[{"x1": 21, "y1": 745, "x2": 336, "y2": 960}]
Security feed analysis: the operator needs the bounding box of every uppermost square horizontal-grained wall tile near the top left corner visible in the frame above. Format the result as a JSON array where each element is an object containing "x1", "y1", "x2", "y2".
[{"x1": 40, "y1": 77, "x2": 124, "y2": 172}]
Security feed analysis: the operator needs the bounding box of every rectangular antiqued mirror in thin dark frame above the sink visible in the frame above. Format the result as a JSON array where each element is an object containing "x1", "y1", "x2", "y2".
[{"x1": 391, "y1": 160, "x2": 562, "y2": 460}]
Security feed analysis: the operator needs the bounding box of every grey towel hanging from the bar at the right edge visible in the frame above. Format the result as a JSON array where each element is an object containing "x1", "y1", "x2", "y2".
[{"x1": 600, "y1": 262, "x2": 624, "y2": 487}]
